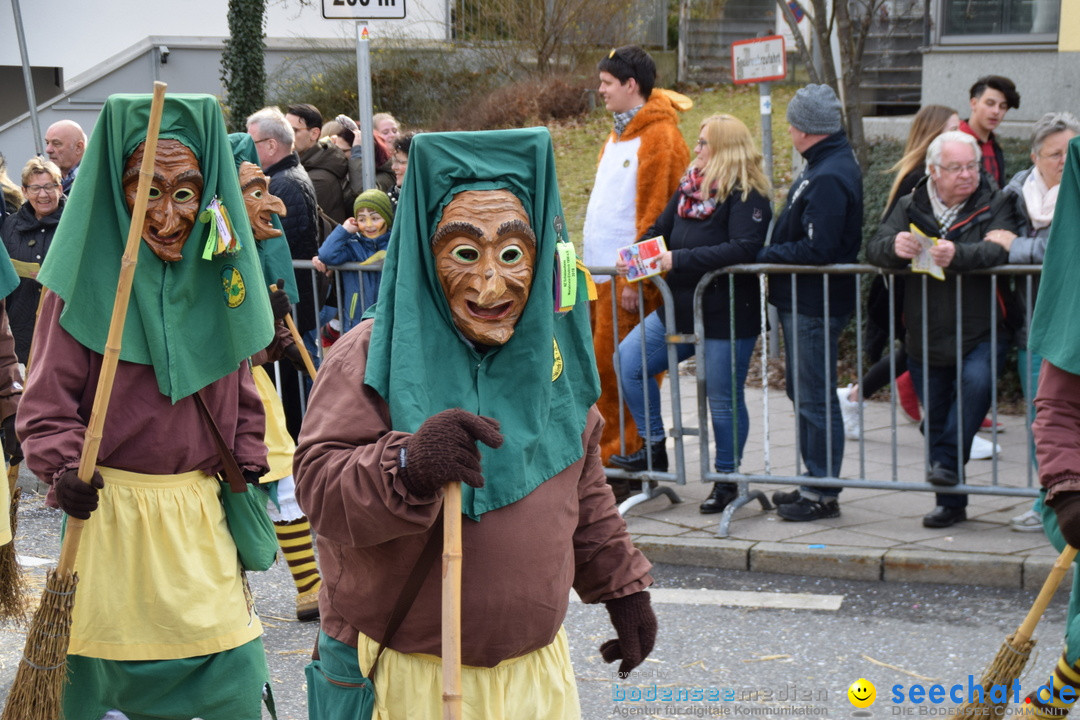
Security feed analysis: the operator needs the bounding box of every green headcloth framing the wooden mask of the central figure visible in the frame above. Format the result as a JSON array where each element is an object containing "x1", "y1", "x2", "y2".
[{"x1": 364, "y1": 127, "x2": 599, "y2": 519}]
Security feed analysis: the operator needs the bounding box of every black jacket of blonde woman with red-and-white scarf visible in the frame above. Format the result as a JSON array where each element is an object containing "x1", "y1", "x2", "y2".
[{"x1": 642, "y1": 190, "x2": 772, "y2": 340}]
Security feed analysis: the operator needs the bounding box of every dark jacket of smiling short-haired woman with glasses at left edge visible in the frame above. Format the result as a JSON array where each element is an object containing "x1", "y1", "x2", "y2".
[{"x1": 0, "y1": 196, "x2": 67, "y2": 363}]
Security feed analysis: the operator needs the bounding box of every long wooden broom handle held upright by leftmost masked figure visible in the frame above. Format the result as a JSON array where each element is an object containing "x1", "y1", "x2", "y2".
[{"x1": 56, "y1": 82, "x2": 165, "y2": 576}]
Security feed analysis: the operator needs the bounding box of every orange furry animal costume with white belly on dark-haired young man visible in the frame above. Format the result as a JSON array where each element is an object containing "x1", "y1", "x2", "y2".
[{"x1": 584, "y1": 89, "x2": 693, "y2": 464}]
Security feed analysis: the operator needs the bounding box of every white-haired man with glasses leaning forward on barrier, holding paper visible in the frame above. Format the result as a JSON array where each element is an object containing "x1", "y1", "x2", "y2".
[{"x1": 866, "y1": 131, "x2": 1020, "y2": 528}]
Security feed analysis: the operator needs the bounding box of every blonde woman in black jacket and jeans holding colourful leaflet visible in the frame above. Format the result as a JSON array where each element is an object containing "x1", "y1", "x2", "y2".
[{"x1": 610, "y1": 114, "x2": 772, "y2": 514}]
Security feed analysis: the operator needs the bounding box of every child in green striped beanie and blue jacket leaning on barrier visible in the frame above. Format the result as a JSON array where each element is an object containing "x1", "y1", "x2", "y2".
[{"x1": 311, "y1": 189, "x2": 394, "y2": 345}]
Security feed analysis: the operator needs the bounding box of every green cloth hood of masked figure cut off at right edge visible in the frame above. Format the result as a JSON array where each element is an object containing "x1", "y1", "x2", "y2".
[{"x1": 1028, "y1": 137, "x2": 1080, "y2": 375}]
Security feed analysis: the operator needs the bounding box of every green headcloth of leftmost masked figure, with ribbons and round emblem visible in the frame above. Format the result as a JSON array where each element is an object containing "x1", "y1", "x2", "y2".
[{"x1": 38, "y1": 94, "x2": 273, "y2": 403}]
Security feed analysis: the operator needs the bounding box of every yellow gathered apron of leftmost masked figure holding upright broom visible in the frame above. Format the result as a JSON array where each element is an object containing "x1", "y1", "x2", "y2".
[{"x1": 68, "y1": 467, "x2": 262, "y2": 661}]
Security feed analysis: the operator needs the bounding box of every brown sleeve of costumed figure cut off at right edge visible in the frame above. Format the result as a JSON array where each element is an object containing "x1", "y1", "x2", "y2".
[{"x1": 1031, "y1": 361, "x2": 1080, "y2": 500}]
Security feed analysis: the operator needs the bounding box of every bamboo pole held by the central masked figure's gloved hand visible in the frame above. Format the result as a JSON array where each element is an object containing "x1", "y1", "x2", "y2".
[{"x1": 443, "y1": 483, "x2": 461, "y2": 720}]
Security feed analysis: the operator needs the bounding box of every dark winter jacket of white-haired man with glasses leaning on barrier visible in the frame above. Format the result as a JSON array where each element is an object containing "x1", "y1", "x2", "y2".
[{"x1": 866, "y1": 173, "x2": 1021, "y2": 367}]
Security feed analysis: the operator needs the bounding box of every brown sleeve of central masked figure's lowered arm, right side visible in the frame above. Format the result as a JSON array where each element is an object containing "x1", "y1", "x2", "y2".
[{"x1": 573, "y1": 406, "x2": 652, "y2": 602}]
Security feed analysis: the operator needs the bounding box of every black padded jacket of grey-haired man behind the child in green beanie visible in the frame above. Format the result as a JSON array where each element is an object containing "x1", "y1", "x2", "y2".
[{"x1": 264, "y1": 152, "x2": 320, "y2": 332}]
